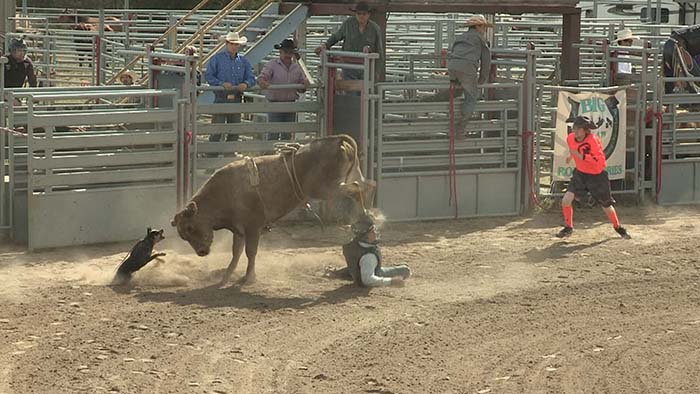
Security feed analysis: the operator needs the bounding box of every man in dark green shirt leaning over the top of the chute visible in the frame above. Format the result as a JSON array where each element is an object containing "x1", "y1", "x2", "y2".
[{"x1": 315, "y1": 1, "x2": 384, "y2": 79}]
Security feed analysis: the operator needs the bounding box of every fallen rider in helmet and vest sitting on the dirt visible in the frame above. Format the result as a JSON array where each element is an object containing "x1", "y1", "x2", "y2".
[{"x1": 342, "y1": 213, "x2": 411, "y2": 287}]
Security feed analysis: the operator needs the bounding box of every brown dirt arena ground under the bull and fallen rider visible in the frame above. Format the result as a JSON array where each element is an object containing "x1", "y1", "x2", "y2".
[{"x1": 0, "y1": 206, "x2": 700, "y2": 394}]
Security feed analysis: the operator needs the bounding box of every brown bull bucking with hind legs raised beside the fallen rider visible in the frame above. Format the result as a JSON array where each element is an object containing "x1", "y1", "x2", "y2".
[{"x1": 171, "y1": 135, "x2": 373, "y2": 285}]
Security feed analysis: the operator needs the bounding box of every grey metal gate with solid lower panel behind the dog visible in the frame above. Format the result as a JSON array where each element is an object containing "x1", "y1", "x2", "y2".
[{"x1": 6, "y1": 88, "x2": 178, "y2": 250}]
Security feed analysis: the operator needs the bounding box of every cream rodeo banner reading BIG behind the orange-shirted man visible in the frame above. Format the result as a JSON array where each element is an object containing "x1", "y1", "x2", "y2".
[{"x1": 552, "y1": 89, "x2": 627, "y2": 181}]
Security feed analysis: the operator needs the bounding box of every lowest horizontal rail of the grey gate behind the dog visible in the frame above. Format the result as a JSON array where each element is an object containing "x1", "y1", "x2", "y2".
[{"x1": 31, "y1": 166, "x2": 176, "y2": 188}]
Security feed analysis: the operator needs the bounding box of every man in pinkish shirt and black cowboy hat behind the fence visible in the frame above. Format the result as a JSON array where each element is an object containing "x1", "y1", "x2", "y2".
[{"x1": 258, "y1": 39, "x2": 309, "y2": 140}]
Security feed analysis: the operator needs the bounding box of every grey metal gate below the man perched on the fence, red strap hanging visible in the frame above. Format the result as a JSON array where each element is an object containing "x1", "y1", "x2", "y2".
[{"x1": 370, "y1": 81, "x2": 523, "y2": 220}]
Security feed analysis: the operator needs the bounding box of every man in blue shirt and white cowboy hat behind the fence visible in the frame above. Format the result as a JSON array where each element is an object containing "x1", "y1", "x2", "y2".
[{"x1": 205, "y1": 31, "x2": 255, "y2": 141}]
